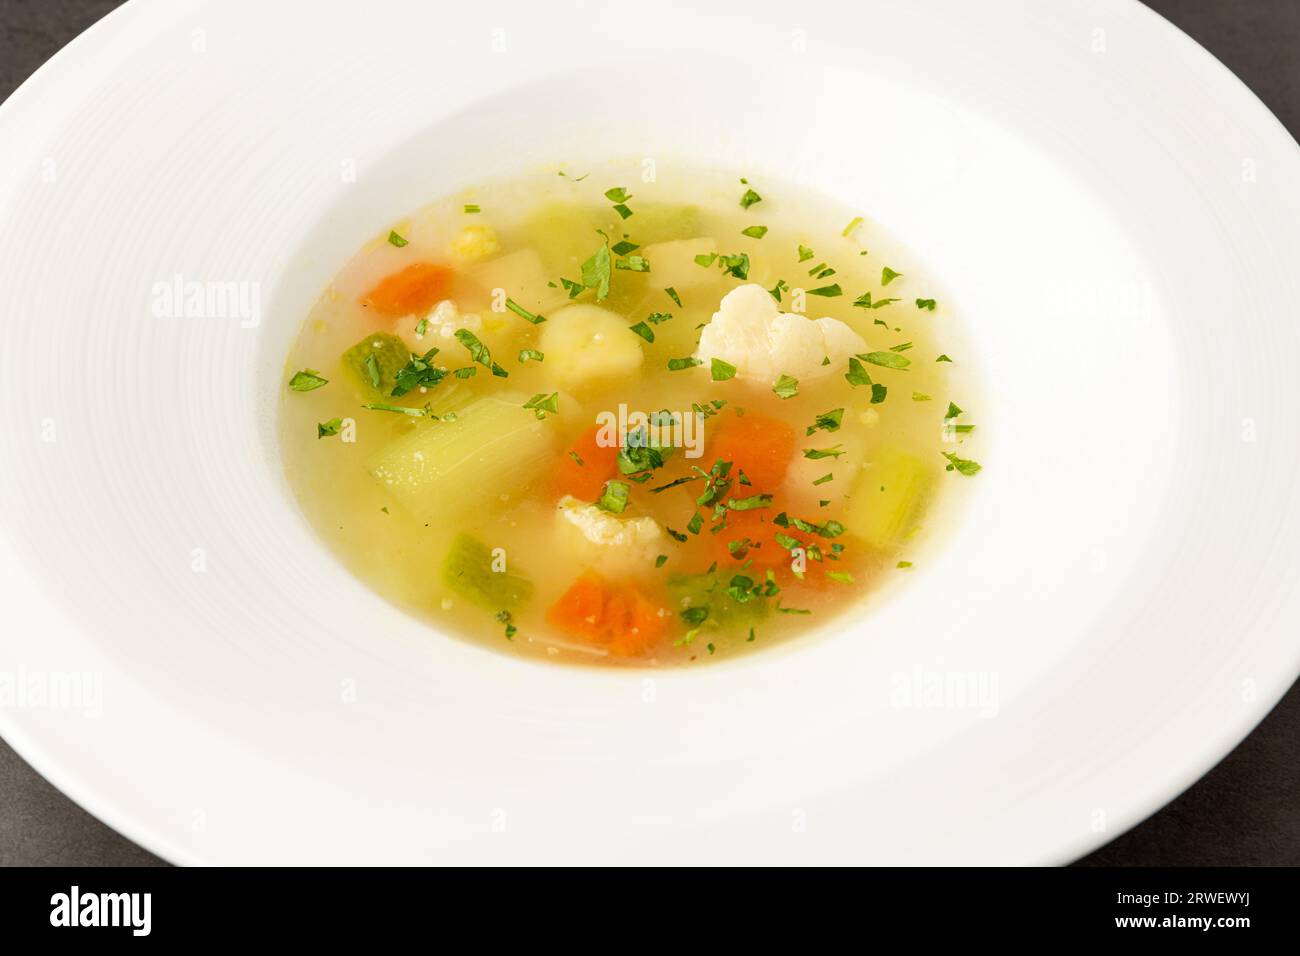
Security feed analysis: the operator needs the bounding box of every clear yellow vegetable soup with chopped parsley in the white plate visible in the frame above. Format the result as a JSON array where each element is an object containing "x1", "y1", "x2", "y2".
[{"x1": 280, "y1": 164, "x2": 980, "y2": 666}]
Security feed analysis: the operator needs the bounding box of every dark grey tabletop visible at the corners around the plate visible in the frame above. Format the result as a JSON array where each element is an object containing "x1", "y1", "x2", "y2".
[{"x1": 0, "y1": 0, "x2": 1300, "y2": 866}]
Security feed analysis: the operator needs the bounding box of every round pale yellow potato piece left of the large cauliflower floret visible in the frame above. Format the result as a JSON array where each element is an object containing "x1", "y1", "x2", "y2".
[{"x1": 540, "y1": 304, "x2": 644, "y2": 390}]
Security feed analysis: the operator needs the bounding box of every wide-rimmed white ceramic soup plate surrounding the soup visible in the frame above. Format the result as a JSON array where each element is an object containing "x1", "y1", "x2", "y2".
[{"x1": 0, "y1": 0, "x2": 1300, "y2": 862}]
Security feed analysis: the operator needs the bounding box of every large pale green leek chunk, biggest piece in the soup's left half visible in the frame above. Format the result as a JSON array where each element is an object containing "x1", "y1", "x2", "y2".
[{"x1": 367, "y1": 394, "x2": 554, "y2": 520}]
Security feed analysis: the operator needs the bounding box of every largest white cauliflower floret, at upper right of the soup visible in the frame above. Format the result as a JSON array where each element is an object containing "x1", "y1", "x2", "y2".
[{"x1": 696, "y1": 282, "x2": 867, "y2": 382}]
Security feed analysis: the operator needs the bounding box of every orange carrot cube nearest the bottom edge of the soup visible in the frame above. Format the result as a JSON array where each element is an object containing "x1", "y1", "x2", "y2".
[{"x1": 546, "y1": 571, "x2": 668, "y2": 657}]
